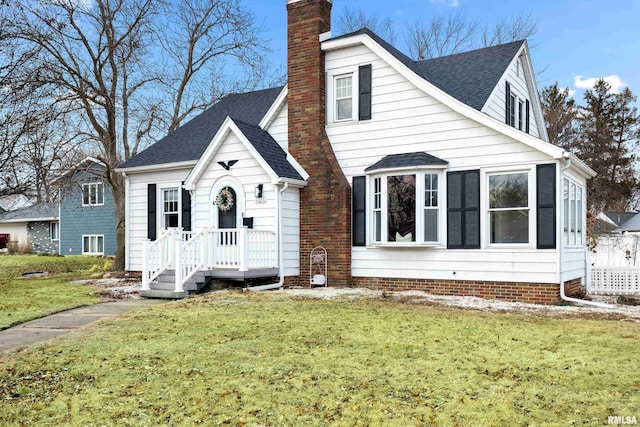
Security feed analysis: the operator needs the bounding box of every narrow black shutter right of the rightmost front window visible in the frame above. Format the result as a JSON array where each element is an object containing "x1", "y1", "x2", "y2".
[{"x1": 536, "y1": 163, "x2": 556, "y2": 249}]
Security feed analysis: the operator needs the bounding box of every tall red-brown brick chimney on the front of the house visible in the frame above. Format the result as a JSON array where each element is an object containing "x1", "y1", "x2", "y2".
[{"x1": 287, "y1": 0, "x2": 351, "y2": 286}]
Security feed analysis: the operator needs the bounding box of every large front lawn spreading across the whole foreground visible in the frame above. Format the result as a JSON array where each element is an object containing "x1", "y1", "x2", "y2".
[{"x1": 0, "y1": 293, "x2": 640, "y2": 426}]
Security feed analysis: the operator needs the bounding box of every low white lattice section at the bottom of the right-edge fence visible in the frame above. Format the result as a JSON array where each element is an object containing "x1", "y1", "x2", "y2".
[{"x1": 587, "y1": 266, "x2": 640, "y2": 295}]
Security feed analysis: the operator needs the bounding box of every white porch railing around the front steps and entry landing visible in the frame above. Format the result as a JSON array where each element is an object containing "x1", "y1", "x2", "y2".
[{"x1": 142, "y1": 228, "x2": 278, "y2": 292}]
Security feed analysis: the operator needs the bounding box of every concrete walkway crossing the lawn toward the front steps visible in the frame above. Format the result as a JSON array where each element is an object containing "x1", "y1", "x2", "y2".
[{"x1": 0, "y1": 299, "x2": 165, "y2": 351}]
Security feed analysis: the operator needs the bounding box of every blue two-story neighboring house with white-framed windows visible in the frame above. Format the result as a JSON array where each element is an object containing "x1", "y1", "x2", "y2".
[{"x1": 56, "y1": 157, "x2": 116, "y2": 255}]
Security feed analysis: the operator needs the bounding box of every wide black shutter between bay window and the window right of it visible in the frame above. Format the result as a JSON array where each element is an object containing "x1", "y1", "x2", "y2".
[{"x1": 447, "y1": 170, "x2": 480, "y2": 249}]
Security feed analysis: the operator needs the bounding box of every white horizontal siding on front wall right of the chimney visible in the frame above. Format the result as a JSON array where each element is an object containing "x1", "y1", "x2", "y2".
[{"x1": 326, "y1": 45, "x2": 559, "y2": 283}]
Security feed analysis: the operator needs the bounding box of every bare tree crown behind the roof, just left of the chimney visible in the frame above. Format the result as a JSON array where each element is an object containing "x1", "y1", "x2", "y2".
[{"x1": 160, "y1": 0, "x2": 267, "y2": 132}]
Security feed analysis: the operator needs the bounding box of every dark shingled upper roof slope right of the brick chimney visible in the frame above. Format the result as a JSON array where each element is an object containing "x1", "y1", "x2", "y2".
[{"x1": 332, "y1": 28, "x2": 524, "y2": 110}]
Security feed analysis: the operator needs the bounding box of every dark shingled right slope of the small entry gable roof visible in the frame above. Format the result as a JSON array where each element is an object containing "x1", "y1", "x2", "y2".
[{"x1": 232, "y1": 119, "x2": 304, "y2": 181}]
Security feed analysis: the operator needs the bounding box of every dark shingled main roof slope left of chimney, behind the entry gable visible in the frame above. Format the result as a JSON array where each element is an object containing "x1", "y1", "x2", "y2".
[{"x1": 120, "y1": 86, "x2": 282, "y2": 168}]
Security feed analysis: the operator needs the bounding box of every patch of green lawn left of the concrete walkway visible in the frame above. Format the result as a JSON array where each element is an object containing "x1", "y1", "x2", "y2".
[{"x1": 0, "y1": 255, "x2": 104, "y2": 330}]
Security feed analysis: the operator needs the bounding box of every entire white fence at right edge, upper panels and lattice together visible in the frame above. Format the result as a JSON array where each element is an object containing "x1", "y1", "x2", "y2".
[{"x1": 587, "y1": 234, "x2": 640, "y2": 295}]
